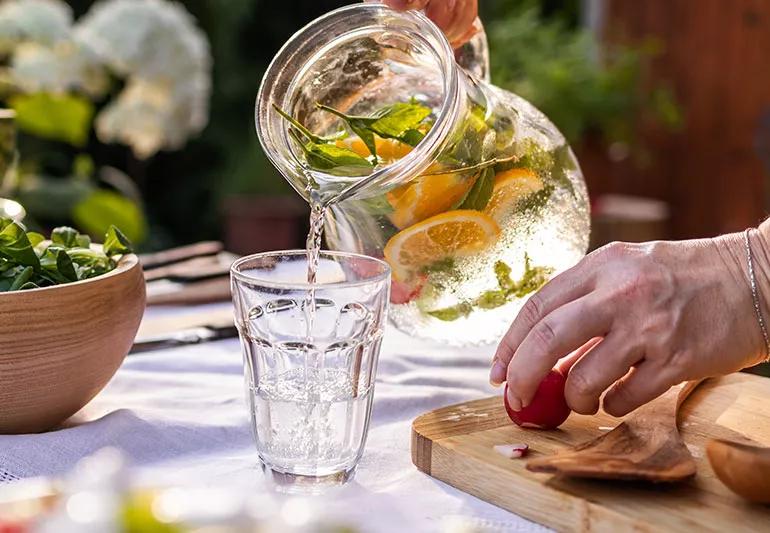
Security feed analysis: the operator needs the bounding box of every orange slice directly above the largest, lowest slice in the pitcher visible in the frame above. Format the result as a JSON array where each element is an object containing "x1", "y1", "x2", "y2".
[{"x1": 388, "y1": 170, "x2": 474, "y2": 229}]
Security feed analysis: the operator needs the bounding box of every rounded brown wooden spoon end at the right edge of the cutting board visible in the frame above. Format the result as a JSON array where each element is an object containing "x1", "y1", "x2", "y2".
[{"x1": 706, "y1": 440, "x2": 770, "y2": 503}]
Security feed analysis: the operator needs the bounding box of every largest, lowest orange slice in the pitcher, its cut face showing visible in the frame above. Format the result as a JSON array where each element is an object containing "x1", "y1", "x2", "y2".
[{"x1": 385, "y1": 209, "x2": 500, "y2": 280}]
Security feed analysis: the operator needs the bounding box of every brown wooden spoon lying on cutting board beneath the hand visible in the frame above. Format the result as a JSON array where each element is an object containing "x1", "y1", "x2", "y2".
[{"x1": 527, "y1": 381, "x2": 700, "y2": 483}]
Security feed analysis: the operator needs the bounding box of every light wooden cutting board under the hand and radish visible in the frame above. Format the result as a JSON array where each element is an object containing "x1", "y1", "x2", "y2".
[{"x1": 412, "y1": 374, "x2": 770, "y2": 533}]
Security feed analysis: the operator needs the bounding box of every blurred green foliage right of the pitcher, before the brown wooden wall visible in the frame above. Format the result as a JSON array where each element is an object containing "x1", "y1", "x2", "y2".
[{"x1": 482, "y1": 0, "x2": 681, "y2": 143}]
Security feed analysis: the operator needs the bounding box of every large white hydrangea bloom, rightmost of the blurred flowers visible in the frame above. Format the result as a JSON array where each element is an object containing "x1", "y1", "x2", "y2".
[{"x1": 74, "y1": 0, "x2": 211, "y2": 157}]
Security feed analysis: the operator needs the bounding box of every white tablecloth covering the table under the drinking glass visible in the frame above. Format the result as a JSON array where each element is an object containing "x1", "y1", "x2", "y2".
[{"x1": 0, "y1": 308, "x2": 544, "y2": 532}]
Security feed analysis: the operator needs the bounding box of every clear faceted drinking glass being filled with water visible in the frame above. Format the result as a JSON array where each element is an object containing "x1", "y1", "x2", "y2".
[{"x1": 226, "y1": 250, "x2": 390, "y2": 491}]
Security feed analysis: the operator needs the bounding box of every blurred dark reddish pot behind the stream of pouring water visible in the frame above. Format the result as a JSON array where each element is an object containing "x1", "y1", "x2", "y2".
[{"x1": 223, "y1": 196, "x2": 310, "y2": 255}]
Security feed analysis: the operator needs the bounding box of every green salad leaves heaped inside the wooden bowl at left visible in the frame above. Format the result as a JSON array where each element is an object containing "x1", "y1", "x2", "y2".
[{"x1": 0, "y1": 218, "x2": 132, "y2": 292}]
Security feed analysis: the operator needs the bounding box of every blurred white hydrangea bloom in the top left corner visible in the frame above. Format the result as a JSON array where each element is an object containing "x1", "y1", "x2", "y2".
[{"x1": 0, "y1": 0, "x2": 72, "y2": 53}]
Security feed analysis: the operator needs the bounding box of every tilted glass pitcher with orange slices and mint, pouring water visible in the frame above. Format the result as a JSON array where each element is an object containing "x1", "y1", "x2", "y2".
[{"x1": 256, "y1": 4, "x2": 589, "y2": 344}]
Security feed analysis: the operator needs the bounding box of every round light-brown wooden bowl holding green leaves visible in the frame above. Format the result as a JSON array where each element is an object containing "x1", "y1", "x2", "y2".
[{"x1": 0, "y1": 255, "x2": 145, "y2": 433}]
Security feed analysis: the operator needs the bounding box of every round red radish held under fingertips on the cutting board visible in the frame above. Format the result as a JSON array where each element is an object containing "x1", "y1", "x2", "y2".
[{"x1": 503, "y1": 369, "x2": 572, "y2": 429}]
